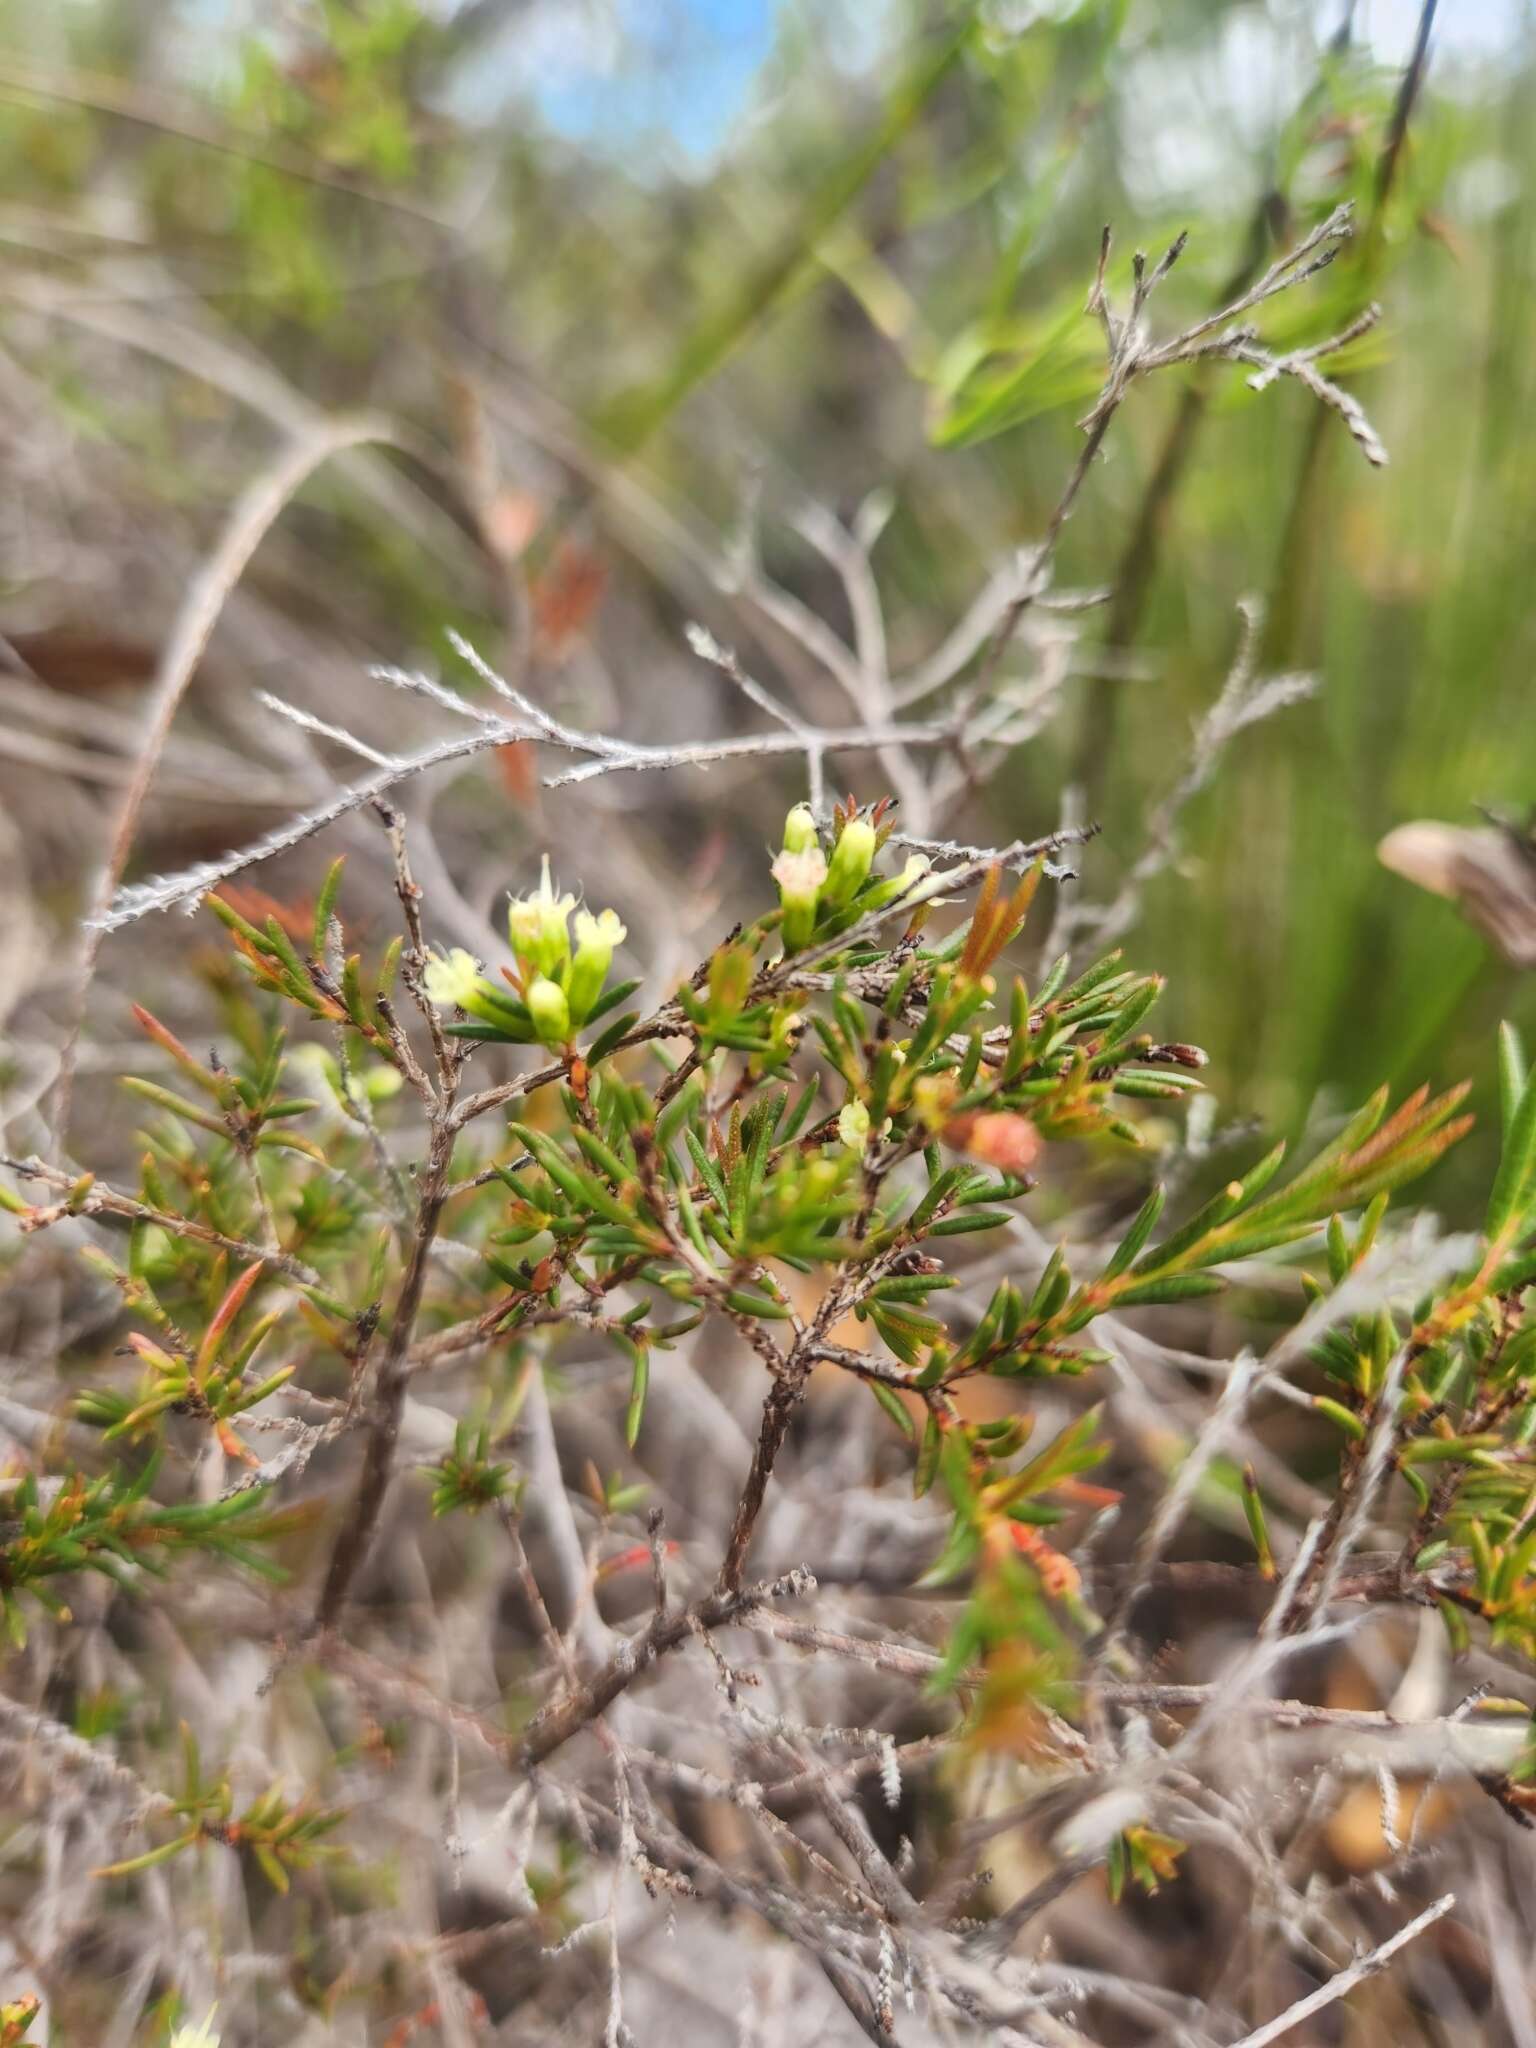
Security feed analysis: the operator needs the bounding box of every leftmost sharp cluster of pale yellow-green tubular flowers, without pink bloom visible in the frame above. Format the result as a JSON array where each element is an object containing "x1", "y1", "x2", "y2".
[{"x1": 426, "y1": 854, "x2": 625, "y2": 1047}]
